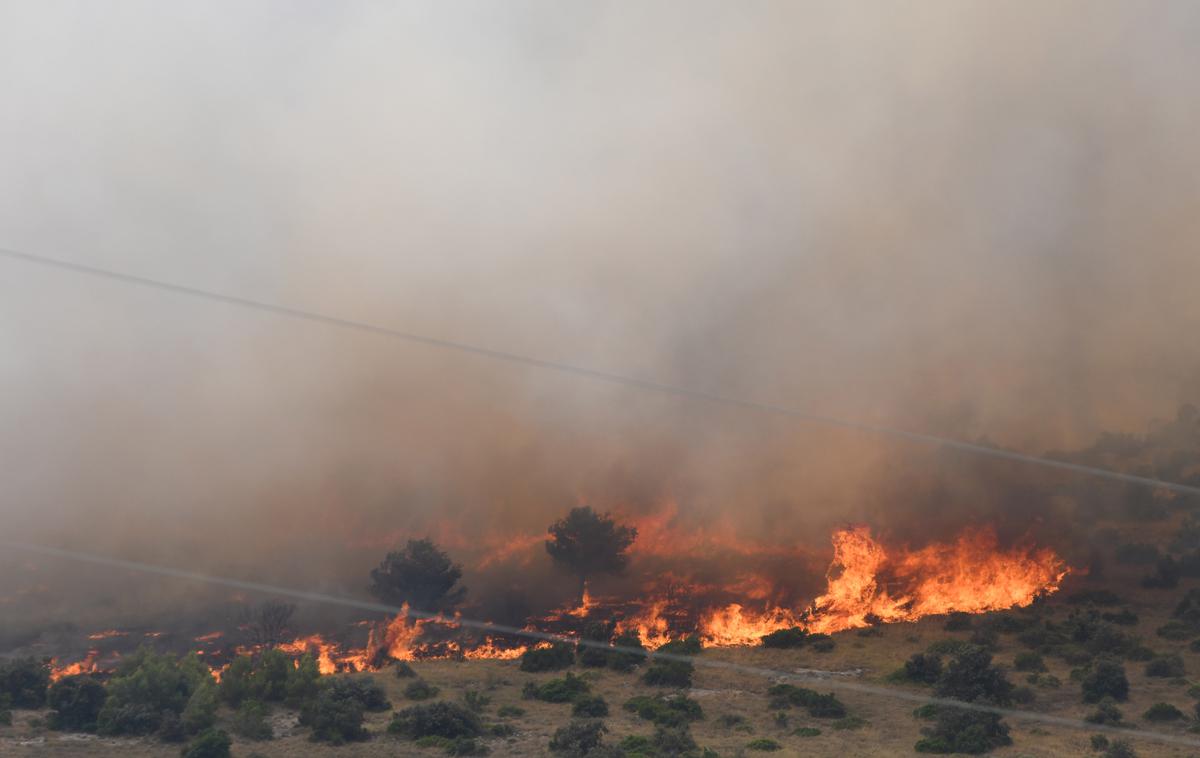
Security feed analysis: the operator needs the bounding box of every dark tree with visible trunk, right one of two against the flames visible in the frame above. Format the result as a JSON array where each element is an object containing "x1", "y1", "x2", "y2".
[{"x1": 546, "y1": 506, "x2": 637, "y2": 603}]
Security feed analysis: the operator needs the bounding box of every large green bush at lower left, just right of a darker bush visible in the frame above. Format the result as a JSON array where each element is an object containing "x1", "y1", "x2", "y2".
[{"x1": 96, "y1": 648, "x2": 211, "y2": 734}]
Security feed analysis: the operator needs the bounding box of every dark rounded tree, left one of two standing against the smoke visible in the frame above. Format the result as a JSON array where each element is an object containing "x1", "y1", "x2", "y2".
[{"x1": 371, "y1": 539, "x2": 467, "y2": 612}]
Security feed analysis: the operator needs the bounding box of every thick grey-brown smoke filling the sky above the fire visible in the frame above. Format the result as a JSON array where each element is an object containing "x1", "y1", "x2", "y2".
[{"x1": 0, "y1": 1, "x2": 1200, "y2": 623}]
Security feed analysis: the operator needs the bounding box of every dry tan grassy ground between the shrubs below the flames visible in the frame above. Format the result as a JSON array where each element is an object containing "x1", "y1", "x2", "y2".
[{"x1": 7, "y1": 578, "x2": 1200, "y2": 757}]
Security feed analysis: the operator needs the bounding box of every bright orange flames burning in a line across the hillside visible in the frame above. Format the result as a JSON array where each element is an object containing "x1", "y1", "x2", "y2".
[{"x1": 46, "y1": 525, "x2": 1070, "y2": 679}]
